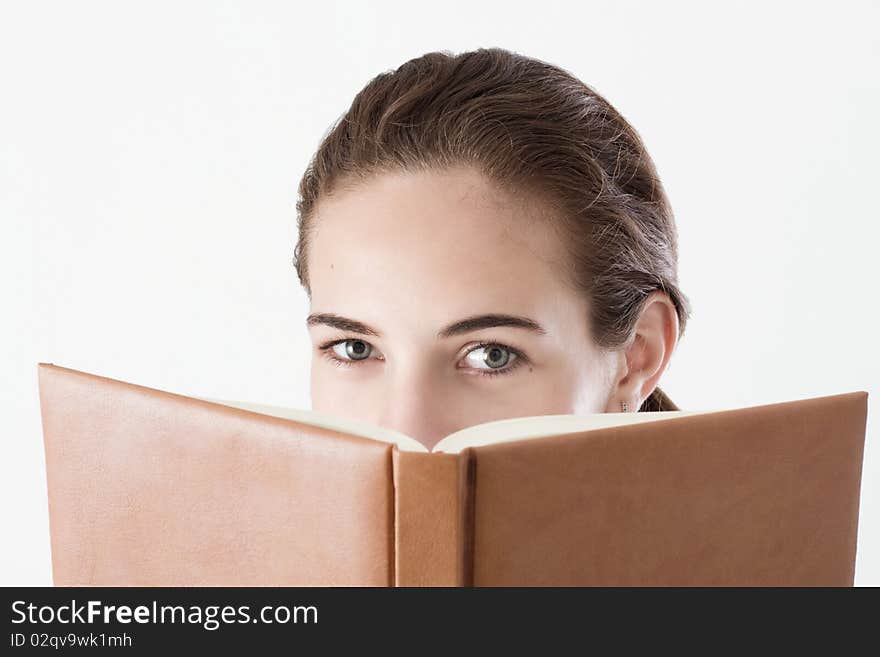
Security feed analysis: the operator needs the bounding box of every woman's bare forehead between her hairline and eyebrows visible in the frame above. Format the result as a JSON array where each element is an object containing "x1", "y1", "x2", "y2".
[{"x1": 309, "y1": 169, "x2": 576, "y2": 325}]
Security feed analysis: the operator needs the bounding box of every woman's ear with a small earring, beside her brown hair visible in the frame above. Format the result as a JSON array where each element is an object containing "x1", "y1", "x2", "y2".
[{"x1": 605, "y1": 290, "x2": 678, "y2": 413}]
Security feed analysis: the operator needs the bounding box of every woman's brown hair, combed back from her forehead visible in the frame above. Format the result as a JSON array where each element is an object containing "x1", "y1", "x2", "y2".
[{"x1": 293, "y1": 48, "x2": 691, "y2": 411}]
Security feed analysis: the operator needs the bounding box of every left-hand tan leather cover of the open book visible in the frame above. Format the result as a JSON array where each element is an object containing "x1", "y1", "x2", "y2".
[{"x1": 39, "y1": 363, "x2": 394, "y2": 586}]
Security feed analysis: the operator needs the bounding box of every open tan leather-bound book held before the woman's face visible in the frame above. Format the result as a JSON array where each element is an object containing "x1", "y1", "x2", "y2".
[{"x1": 38, "y1": 363, "x2": 868, "y2": 586}]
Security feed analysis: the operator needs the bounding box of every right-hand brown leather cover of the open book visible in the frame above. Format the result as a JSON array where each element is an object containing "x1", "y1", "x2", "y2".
[{"x1": 468, "y1": 391, "x2": 868, "y2": 586}]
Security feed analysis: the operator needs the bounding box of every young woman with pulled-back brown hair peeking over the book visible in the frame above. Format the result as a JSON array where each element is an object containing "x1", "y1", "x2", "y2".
[{"x1": 294, "y1": 43, "x2": 690, "y2": 448}]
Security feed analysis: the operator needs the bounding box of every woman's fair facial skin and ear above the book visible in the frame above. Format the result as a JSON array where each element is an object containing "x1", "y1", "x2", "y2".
[{"x1": 307, "y1": 168, "x2": 678, "y2": 449}]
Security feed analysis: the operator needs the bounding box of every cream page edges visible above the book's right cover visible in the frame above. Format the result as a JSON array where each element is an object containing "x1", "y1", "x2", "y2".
[{"x1": 431, "y1": 411, "x2": 717, "y2": 454}]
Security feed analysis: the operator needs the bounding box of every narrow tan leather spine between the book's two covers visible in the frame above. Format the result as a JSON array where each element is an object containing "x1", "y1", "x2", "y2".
[{"x1": 392, "y1": 447, "x2": 473, "y2": 586}]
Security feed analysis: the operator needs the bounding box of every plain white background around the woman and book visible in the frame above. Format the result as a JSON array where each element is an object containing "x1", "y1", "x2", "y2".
[{"x1": 0, "y1": 0, "x2": 880, "y2": 586}]
